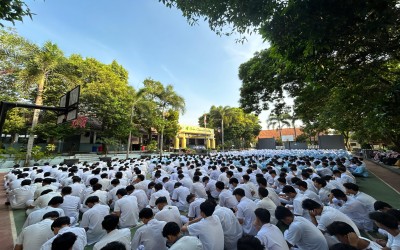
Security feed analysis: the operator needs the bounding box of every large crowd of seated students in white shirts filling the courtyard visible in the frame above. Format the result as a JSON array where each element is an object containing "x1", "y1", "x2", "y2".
[{"x1": 5, "y1": 150, "x2": 400, "y2": 250}]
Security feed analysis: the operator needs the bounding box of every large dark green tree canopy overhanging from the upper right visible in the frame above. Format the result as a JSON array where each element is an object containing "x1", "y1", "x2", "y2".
[{"x1": 160, "y1": 0, "x2": 400, "y2": 149}]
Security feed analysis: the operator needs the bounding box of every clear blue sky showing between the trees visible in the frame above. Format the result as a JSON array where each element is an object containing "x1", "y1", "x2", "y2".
[{"x1": 9, "y1": 0, "x2": 290, "y2": 129}]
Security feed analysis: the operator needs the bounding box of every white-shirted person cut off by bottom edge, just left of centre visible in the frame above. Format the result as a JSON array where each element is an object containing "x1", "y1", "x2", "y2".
[{"x1": 162, "y1": 222, "x2": 203, "y2": 250}]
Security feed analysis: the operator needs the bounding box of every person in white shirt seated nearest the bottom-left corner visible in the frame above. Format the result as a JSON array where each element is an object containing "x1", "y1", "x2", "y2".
[{"x1": 14, "y1": 211, "x2": 59, "y2": 250}]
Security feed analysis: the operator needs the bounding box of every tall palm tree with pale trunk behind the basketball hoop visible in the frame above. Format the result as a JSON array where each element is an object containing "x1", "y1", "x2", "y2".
[{"x1": 19, "y1": 42, "x2": 64, "y2": 163}]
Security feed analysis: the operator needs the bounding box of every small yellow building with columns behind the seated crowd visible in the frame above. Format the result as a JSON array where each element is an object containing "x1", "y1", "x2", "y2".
[{"x1": 174, "y1": 125, "x2": 215, "y2": 150}]
